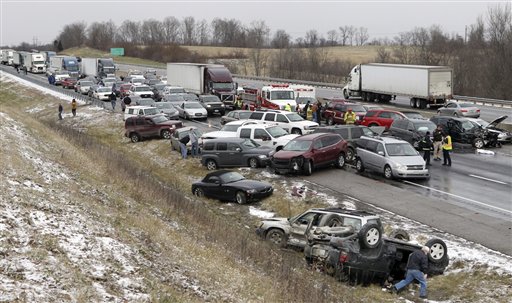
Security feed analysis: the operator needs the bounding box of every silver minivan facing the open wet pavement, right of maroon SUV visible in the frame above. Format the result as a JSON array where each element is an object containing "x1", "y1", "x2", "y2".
[{"x1": 356, "y1": 136, "x2": 430, "y2": 179}]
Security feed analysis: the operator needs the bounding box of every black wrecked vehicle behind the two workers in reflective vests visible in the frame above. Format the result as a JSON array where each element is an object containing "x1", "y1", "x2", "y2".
[{"x1": 430, "y1": 116, "x2": 489, "y2": 148}]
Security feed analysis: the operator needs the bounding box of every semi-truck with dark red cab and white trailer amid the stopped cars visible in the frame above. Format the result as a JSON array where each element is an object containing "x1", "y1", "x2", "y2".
[{"x1": 167, "y1": 63, "x2": 237, "y2": 107}]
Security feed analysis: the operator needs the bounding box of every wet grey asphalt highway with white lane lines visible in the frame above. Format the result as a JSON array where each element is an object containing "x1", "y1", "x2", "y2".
[{"x1": 1, "y1": 66, "x2": 512, "y2": 255}]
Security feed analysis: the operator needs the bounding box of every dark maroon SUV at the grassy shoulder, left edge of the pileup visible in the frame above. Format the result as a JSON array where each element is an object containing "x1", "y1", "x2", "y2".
[{"x1": 124, "y1": 114, "x2": 183, "y2": 143}]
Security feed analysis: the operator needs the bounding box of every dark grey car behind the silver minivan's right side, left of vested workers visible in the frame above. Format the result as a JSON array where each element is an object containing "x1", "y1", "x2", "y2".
[{"x1": 389, "y1": 119, "x2": 436, "y2": 150}]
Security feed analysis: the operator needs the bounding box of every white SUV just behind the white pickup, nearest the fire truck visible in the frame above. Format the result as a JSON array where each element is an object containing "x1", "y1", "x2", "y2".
[{"x1": 249, "y1": 110, "x2": 318, "y2": 135}]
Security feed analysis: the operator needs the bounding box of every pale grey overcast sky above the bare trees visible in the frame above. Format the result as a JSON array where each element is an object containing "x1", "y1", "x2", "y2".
[{"x1": 0, "y1": 0, "x2": 511, "y2": 45}]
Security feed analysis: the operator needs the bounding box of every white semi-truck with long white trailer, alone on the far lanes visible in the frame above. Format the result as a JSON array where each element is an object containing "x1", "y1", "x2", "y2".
[{"x1": 343, "y1": 63, "x2": 453, "y2": 109}]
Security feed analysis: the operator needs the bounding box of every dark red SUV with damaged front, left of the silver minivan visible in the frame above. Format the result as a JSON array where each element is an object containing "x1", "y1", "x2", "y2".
[{"x1": 271, "y1": 133, "x2": 347, "y2": 176}]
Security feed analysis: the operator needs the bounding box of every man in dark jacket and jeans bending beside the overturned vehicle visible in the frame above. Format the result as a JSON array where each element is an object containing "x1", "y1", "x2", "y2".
[{"x1": 391, "y1": 246, "x2": 430, "y2": 299}]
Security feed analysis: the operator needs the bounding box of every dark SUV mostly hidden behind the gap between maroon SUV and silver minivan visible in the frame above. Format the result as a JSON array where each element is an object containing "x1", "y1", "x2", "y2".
[{"x1": 313, "y1": 125, "x2": 380, "y2": 162}]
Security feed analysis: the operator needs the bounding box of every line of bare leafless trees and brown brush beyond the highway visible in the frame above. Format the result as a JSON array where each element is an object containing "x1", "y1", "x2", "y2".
[{"x1": 6, "y1": 3, "x2": 512, "y2": 99}]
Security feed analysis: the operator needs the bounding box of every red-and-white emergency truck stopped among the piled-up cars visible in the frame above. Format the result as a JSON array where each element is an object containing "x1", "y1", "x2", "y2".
[{"x1": 242, "y1": 84, "x2": 297, "y2": 111}]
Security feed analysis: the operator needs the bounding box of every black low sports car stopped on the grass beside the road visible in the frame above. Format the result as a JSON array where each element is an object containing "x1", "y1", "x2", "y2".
[{"x1": 192, "y1": 170, "x2": 274, "y2": 204}]
